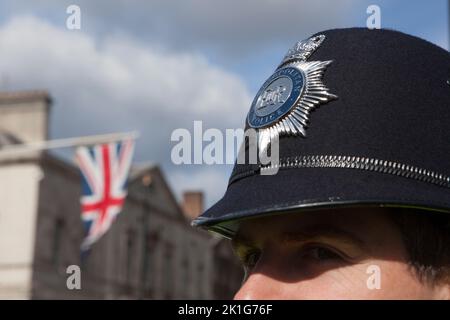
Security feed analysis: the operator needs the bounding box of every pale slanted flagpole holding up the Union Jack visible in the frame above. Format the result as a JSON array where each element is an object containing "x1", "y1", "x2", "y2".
[{"x1": 0, "y1": 131, "x2": 139, "y2": 157}]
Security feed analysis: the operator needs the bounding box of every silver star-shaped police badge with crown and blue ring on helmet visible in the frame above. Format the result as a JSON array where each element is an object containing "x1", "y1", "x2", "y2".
[{"x1": 247, "y1": 35, "x2": 337, "y2": 151}]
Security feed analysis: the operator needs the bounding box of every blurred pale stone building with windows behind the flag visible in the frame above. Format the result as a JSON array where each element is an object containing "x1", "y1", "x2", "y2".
[{"x1": 0, "y1": 92, "x2": 242, "y2": 299}]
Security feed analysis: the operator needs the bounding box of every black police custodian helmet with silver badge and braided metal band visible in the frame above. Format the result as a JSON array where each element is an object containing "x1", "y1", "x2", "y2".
[{"x1": 192, "y1": 28, "x2": 450, "y2": 237}]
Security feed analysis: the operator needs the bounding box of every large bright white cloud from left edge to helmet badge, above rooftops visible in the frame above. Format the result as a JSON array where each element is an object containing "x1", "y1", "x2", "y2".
[{"x1": 0, "y1": 16, "x2": 251, "y2": 205}]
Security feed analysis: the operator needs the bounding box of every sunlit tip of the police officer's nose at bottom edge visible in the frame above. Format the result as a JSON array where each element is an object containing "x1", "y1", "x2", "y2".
[{"x1": 234, "y1": 273, "x2": 282, "y2": 300}]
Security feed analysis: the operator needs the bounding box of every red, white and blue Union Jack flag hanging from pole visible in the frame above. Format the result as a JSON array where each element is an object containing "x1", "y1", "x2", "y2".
[{"x1": 76, "y1": 140, "x2": 134, "y2": 250}]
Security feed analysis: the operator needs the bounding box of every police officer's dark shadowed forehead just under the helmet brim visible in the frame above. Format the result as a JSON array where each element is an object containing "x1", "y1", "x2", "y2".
[{"x1": 234, "y1": 207, "x2": 398, "y2": 241}]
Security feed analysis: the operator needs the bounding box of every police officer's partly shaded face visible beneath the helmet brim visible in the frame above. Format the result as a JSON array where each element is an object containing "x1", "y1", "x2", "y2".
[{"x1": 233, "y1": 209, "x2": 448, "y2": 299}]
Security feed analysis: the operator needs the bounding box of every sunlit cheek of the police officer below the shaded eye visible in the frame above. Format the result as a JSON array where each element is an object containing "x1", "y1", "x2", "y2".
[{"x1": 278, "y1": 260, "x2": 431, "y2": 299}]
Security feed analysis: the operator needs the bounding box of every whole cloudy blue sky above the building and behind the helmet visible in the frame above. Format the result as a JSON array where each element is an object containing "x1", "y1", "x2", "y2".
[{"x1": 0, "y1": 0, "x2": 449, "y2": 206}]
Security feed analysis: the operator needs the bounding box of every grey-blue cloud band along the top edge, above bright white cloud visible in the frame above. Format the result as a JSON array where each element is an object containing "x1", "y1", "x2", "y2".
[{"x1": 0, "y1": 0, "x2": 358, "y2": 56}]
